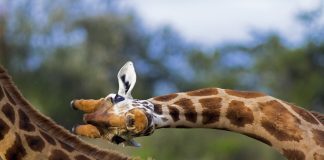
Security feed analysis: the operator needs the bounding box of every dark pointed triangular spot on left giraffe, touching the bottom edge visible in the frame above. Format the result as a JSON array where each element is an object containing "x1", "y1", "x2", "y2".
[{"x1": 5, "y1": 133, "x2": 27, "y2": 160}]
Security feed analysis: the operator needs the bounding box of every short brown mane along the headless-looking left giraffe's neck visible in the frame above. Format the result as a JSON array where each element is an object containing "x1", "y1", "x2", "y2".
[{"x1": 0, "y1": 65, "x2": 129, "y2": 160}]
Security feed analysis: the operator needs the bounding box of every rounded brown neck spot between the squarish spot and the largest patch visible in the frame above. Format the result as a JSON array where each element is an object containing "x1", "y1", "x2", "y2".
[{"x1": 226, "y1": 100, "x2": 254, "y2": 127}]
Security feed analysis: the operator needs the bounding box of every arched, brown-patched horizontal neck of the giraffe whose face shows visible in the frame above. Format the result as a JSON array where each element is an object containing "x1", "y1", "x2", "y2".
[{"x1": 149, "y1": 88, "x2": 324, "y2": 160}]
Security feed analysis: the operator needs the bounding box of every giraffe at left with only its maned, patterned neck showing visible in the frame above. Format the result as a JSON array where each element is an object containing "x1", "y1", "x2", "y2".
[{"x1": 0, "y1": 65, "x2": 130, "y2": 160}]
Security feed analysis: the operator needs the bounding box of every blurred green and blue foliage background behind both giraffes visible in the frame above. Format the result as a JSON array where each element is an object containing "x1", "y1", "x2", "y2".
[{"x1": 0, "y1": 0, "x2": 324, "y2": 160}]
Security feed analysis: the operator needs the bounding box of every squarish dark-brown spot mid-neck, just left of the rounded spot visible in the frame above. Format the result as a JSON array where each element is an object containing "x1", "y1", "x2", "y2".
[{"x1": 199, "y1": 97, "x2": 222, "y2": 124}]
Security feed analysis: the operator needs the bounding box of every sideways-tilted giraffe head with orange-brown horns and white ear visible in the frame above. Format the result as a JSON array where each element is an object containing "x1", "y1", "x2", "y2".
[{"x1": 71, "y1": 62, "x2": 154, "y2": 146}]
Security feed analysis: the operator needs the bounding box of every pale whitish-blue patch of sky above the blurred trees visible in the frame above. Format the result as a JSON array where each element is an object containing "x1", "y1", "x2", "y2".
[{"x1": 120, "y1": 0, "x2": 320, "y2": 46}]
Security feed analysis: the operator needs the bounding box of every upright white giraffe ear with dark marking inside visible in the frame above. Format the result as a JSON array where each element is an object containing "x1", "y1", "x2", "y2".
[{"x1": 117, "y1": 61, "x2": 136, "y2": 98}]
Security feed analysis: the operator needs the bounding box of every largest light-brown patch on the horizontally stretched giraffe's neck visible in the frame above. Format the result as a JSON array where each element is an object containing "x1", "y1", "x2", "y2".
[{"x1": 259, "y1": 100, "x2": 302, "y2": 141}]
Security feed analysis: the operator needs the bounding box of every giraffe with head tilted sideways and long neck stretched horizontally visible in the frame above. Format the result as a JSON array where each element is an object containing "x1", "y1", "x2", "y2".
[{"x1": 71, "y1": 62, "x2": 324, "y2": 160}]
